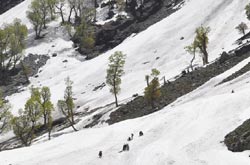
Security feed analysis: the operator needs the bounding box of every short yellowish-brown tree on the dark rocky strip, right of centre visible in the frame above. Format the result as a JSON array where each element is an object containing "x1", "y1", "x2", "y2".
[{"x1": 144, "y1": 69, "x2": 161, "y2": 109}]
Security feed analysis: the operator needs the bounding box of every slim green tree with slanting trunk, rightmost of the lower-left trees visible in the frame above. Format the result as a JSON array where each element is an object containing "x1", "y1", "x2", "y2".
[{"x1": 57, "y1": 77, "x2": 77, "y2": 131}]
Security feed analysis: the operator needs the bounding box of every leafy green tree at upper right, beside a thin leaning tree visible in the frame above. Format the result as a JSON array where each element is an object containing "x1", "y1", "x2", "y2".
[{"x1": 194, "y1": 26, "x2": 210, "y2": 65}]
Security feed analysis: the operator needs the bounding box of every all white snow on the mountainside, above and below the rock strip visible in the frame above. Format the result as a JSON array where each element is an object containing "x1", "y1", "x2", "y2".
[{"x1": 0, "y1": 0, "x2": 250, "y2": 165}]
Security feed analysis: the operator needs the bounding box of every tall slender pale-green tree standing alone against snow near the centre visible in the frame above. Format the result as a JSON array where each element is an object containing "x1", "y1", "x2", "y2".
[{"x1": 106, "y1": 51, "x2": 126, "y2": 107}]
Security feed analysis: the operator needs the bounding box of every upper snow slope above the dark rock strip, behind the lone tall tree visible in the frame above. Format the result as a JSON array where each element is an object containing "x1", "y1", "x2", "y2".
[{"x1": 0, "y1": 0, "x2": 247, "y2": 111}]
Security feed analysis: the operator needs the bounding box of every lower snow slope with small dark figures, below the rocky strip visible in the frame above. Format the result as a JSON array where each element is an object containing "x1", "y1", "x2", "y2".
[{"x1": 0, "y1": 59, "x2": 250, "y2": 165}]
